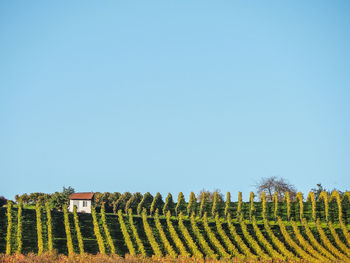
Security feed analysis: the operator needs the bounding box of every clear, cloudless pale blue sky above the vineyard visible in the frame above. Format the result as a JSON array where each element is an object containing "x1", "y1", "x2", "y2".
[{"x1": 0, "y1": 0, "x2": 350, "y2": 199}]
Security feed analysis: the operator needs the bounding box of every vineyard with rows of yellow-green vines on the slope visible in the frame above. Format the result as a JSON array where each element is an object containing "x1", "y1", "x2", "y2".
[{"x1": 0, "y1": 191, "x2": 350, "y2": 262}]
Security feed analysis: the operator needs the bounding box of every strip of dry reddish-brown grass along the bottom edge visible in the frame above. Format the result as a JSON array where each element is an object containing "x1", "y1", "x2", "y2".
[{"x1": 0, "y1": 253, "x2": 307, "y2": 263}]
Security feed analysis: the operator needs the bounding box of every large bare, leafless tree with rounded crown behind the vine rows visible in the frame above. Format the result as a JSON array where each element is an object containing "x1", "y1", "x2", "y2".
[{"x1": 255, "y1": 176, "x2": 297, "y2": 201}]
